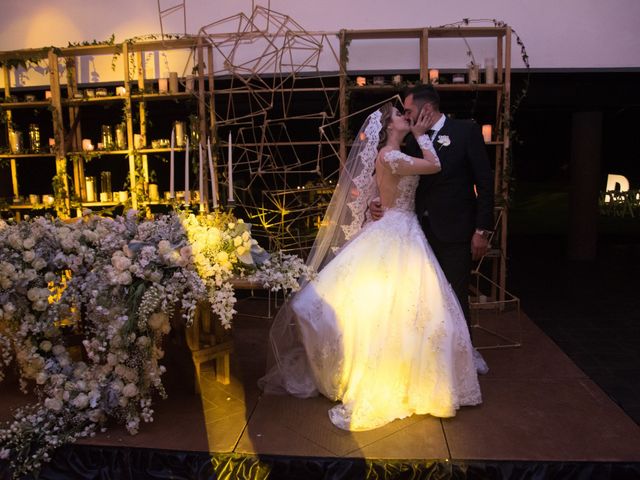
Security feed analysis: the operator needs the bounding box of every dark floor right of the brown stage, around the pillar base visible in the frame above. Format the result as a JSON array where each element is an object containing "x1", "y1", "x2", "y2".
[{"x1": 508, "y1": 235, "x2": 640, "y2": 424}]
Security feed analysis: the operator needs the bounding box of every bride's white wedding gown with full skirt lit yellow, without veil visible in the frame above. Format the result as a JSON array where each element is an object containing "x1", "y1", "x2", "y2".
[{"x1": 263, "y1": 152, "x2": 482, "y2": 430}]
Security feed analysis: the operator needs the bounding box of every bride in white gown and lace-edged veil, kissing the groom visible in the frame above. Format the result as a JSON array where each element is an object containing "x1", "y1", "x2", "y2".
[{"x1": 259, "y1": 103, "x2": 482, "y2": 431}]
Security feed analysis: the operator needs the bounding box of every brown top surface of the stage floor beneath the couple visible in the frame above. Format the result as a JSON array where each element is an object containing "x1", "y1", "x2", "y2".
[{"x1": 0, "y1": 300, "x2": 640, "y2": 472}]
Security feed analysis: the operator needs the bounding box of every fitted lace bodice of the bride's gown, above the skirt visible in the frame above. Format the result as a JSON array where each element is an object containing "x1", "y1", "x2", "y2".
[{"x1": 377, "y1": 150, "x2": 420, "y2": 212}]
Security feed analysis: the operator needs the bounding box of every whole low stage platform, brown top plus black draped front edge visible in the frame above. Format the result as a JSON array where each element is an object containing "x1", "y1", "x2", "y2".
[{"x1": 0, "y1": 299, "x2": 640, "y2": 479}]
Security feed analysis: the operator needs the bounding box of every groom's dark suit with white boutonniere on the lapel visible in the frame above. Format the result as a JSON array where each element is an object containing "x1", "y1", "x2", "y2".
[{"x1": 406, "y1": 118, "x2": 494, "y2": 320}]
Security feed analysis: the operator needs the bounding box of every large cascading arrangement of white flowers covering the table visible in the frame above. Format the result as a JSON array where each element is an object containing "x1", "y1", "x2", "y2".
[{"x1": 0, "y1": 211, "x2": 310, "y2": 476}]
